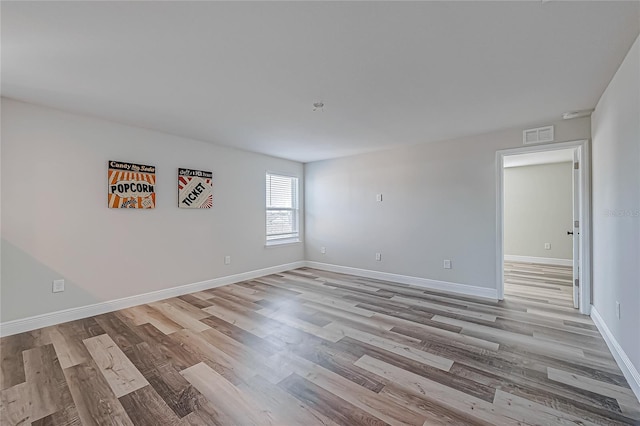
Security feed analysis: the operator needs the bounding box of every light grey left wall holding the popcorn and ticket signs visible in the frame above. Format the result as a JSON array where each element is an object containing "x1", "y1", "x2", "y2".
[{"x1": 0, "y1": 99, "x2": 304, "y2": 322}]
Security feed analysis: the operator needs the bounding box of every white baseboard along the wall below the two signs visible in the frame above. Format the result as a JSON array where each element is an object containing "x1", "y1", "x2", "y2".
[{"x1": 0, "y1": 261, "x2": 305, "y2": 337}]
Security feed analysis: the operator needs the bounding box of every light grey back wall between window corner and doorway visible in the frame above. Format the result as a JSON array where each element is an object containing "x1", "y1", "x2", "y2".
[{"x1": 305, "y1": 118, "x2": 590, "y2": 289}]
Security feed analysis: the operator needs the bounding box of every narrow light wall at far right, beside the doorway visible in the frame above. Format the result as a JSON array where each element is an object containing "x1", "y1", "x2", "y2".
[{"x1": 592, "y1": 39, "x2": 640, "y2": 378}]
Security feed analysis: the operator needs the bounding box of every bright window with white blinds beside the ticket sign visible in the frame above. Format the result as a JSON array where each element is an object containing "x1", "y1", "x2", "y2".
[{"x1": 266, "y1": 173, "x2": 300, "y2": 245}]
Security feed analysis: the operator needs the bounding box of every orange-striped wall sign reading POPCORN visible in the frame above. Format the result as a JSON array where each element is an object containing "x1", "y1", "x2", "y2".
[{"x1": 108, "y1": 161, "x2": 156, "y2": 209}]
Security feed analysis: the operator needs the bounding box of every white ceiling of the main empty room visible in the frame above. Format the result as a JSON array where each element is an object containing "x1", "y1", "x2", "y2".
[{"x1": 1, "y1": 1, "x2": 640, "y2": 162}]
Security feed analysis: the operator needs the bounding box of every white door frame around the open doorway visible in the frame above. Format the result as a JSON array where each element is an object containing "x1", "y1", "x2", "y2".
[{"x1": 496, "y1": 139, "x2": 591, "y2": 315}]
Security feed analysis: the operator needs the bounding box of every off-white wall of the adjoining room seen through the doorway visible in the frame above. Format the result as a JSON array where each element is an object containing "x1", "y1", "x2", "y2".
[{"x1": 504, "y1": 162, "x2": 573, "y2": 259}]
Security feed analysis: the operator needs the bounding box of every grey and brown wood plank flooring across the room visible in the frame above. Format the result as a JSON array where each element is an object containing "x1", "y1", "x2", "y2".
[{"x1": 0, "y1": 264, "x2": 640, "y2": 426}]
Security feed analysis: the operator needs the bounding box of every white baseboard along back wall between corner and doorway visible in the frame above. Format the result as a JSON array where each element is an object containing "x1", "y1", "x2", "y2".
[{"x1": 306, "y1": 261, "x2": 498, "y2": 300}]
